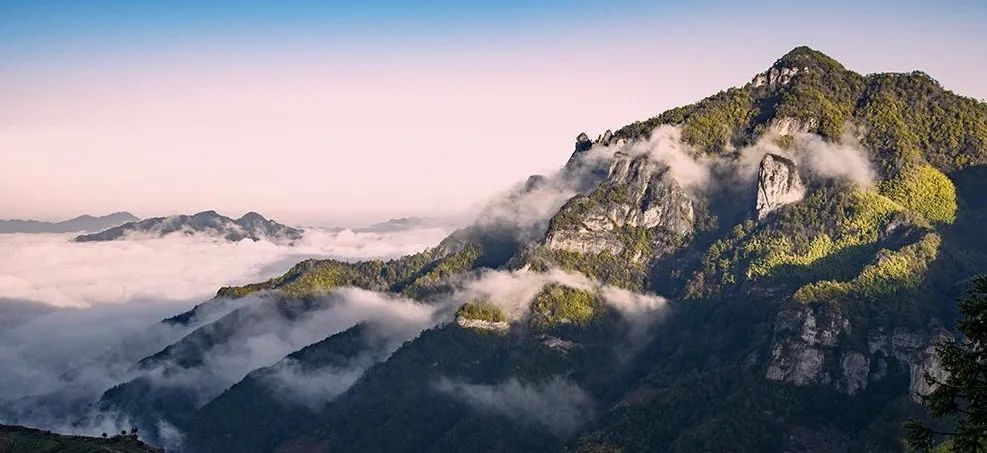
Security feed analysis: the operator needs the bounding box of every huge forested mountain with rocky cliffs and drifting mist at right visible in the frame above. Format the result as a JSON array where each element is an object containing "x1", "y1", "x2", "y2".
[{"x1": 30, "y1": 47, "x2": 987, "y2": 452}]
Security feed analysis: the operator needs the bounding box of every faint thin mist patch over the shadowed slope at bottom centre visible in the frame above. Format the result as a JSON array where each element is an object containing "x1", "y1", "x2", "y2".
[{"x1": 434, "y1": 377, "x2": 593, "y2": 438}]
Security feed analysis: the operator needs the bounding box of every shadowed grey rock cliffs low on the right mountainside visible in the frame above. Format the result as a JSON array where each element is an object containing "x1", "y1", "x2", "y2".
[{"x1": 765, "y1": 307, "x2": 947, "y2": 402}]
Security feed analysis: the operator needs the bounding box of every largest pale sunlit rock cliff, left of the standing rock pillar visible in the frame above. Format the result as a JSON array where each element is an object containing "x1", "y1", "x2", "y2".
[{"x1": 545, "y1": 152, "x2": 695, "y2": 258}]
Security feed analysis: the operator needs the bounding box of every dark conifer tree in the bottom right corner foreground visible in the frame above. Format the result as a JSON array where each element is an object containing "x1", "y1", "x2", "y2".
[{"x1": 905, "y1": 276, "x2": 987, "y2": 452}]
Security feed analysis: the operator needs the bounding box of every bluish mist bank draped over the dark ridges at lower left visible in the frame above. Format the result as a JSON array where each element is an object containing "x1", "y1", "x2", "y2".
[{"x1": 94, "y1": 288, "x2": 441, "y2": 441}]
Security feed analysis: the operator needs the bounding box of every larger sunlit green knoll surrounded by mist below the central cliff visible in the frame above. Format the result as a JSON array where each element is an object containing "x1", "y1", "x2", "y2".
[{"x1": 529, "y1": 284, "x2": 600, "y2": 330}]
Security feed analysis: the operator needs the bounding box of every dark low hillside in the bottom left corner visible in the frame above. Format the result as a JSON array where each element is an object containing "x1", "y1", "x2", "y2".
[{"x1": 0, "y1": 425, "x2": 162, "y2": 453}]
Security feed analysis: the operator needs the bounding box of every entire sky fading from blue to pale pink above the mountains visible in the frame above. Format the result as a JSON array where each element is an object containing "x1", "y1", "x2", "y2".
[{"x1": 0, "y1": 0, "x2": 987, "y2": 225}]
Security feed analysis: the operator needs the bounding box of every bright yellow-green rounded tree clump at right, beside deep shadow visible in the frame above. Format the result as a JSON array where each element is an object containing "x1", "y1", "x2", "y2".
[{"x1": 880, "y1": 165, "x2": 956, "y2": 223}]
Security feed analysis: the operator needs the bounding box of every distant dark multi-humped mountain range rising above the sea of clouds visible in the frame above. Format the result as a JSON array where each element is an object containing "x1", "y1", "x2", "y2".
[{"x1": 75, "y1": 211, "x2": 303, "y2": 242}]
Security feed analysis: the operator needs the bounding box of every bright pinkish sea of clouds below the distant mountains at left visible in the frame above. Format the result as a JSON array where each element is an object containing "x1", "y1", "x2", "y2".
[{"x1": 0, "y1": 227, "x2": 448, "y2": 307}]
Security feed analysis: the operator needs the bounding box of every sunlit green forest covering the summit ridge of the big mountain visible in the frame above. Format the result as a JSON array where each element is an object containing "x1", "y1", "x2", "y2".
[{"x1": 616, "y1": 47, "x2": 987, "y2": 174}]
